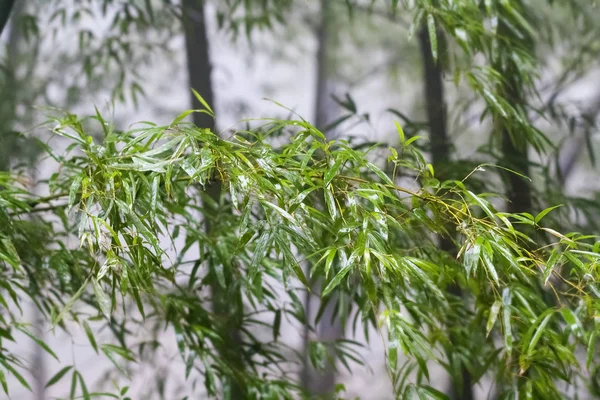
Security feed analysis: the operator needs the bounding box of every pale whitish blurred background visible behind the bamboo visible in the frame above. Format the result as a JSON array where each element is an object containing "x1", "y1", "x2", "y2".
[{"x1": 0, "y1": 0, "x2": 600, "y2": 400}]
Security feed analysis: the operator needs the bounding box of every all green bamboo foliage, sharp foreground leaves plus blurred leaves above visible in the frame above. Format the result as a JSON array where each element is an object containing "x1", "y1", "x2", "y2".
[{"x1": 0, "y1": 0, "x2": 600, "y2": 399}]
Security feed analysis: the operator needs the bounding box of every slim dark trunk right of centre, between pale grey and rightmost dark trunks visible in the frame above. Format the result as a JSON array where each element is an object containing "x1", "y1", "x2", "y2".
[{"x1": 419, "y1": 25, "x2": 473, "y2": 400}]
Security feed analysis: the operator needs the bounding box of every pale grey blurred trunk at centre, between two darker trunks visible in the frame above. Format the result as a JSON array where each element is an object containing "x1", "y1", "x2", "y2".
[{"x1": 302, "y1": 0, "x2": 344, "y2": 395}]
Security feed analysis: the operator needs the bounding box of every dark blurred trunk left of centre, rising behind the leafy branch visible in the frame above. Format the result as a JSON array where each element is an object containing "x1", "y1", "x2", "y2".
[{"x1": 182, "y1": 0, "x2": 247, "y2": 400}]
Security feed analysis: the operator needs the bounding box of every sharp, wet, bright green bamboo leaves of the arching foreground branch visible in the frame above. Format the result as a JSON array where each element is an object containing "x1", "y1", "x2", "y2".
[{"x1": 0, "y1": 99, "x2": 600, "y2": 398}]
